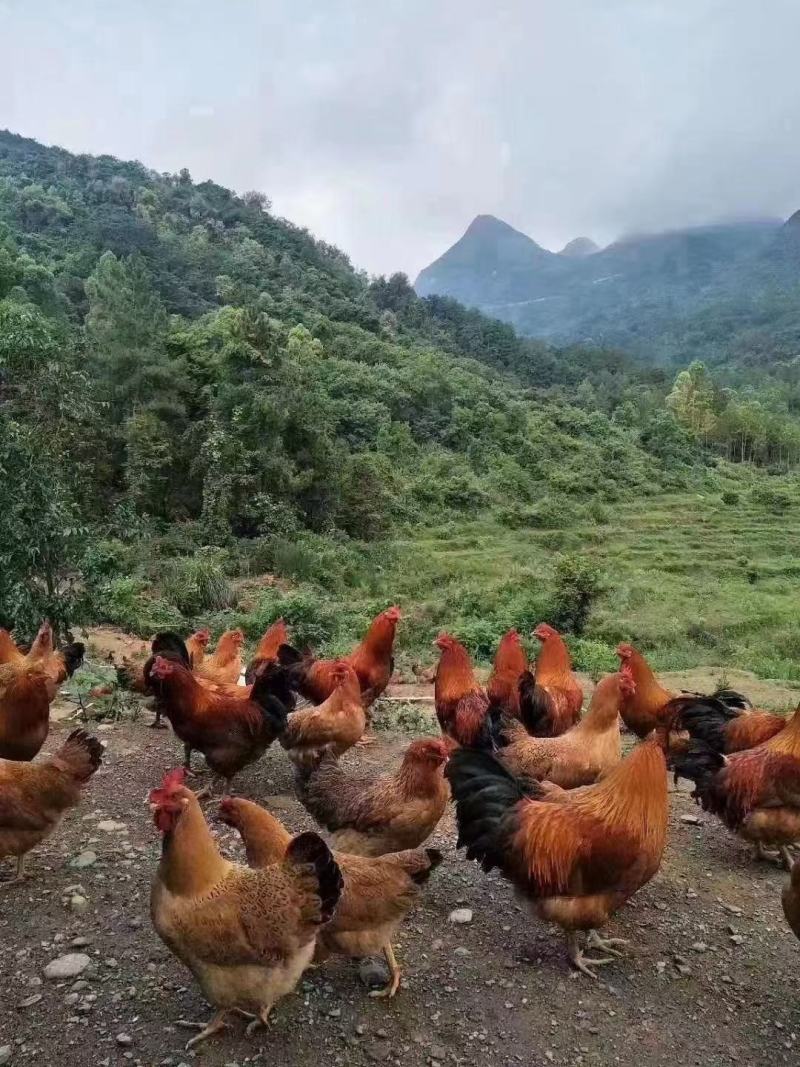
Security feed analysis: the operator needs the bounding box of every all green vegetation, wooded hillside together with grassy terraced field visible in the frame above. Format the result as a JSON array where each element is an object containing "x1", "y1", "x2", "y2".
[{"x1": 0, "y1": 133, "x2": 798, "y2": 676}]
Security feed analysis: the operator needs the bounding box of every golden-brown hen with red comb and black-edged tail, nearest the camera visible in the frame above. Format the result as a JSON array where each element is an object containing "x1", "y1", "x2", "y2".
[{"x1": 150, "y1": 770, "x2": 342, "y2": 1048}]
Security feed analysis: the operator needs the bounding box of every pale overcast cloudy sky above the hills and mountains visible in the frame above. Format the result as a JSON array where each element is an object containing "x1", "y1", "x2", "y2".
[{"x1": 0, "y1": 0, "x2": 800, "y2": 277}]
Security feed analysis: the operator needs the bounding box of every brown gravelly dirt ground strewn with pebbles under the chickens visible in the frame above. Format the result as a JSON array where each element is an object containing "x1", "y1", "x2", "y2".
[{"x1": 0, "y1": 689, "x2": 800, "y2": 1067}]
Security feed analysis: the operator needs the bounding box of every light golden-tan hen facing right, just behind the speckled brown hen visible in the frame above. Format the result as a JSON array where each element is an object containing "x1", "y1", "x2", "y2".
[{"x1": 279, "y1": 660, "x2": 366, "y2": 767}]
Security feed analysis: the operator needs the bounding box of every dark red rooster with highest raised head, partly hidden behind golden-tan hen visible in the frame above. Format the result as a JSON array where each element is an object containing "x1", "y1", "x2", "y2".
[{"x1": 279, "y1": 607, "x2": 401, "y2": 708}]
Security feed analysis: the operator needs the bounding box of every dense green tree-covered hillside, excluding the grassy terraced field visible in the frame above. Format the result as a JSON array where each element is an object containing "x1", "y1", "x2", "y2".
[{"x1": 0, "y1": 126, "x2": 798, "y2": 665}]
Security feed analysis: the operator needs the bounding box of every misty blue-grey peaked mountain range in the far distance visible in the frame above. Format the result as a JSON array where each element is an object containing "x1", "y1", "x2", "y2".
[{"x1": 415, "y1": 211, "x2": 800, "y2": 363}]
